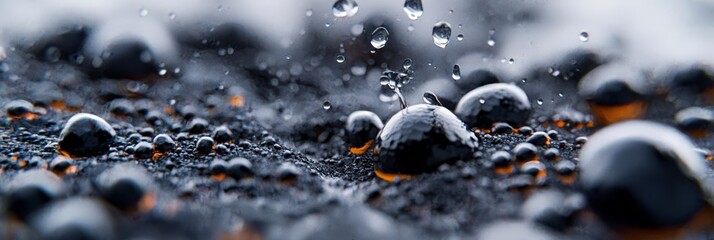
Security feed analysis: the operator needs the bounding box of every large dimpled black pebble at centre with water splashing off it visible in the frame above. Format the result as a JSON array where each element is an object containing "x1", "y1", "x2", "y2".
[{"x1": 375, "y1": 104, "x2": 478, "y2": 175}]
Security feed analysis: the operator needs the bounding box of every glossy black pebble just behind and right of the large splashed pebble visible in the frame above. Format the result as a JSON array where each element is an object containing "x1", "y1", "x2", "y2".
[{"x1": 454, "y1": 83, "x2": 532, "y2": 129}]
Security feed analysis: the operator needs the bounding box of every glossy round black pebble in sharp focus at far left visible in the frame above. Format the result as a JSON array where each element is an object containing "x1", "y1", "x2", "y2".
[{"x1": 57, "y1": 113, "x2": 116, "y2": 157}]
